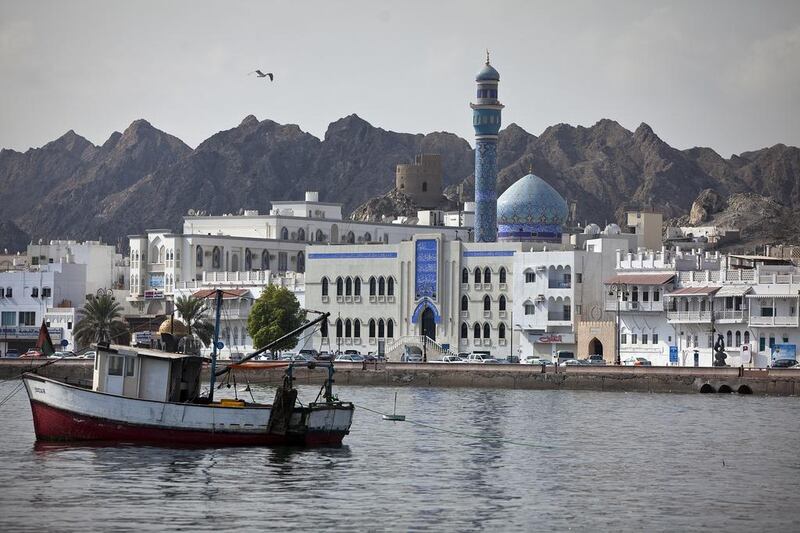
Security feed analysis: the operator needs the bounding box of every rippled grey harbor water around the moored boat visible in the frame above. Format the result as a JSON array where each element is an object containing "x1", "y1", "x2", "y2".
[{"x1": 0, "y1": 381, "x2": 800, "y2": 531}]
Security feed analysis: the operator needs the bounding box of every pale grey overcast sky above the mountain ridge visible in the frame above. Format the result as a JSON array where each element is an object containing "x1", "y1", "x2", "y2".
[{"x1": 0, "y1": 0, "x2": 800, "y2": 157}]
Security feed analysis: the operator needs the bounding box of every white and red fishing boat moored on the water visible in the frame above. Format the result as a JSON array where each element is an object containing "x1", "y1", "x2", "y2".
[{"x1": 22, "y1": 302, "x2": 354, "y2": 446}]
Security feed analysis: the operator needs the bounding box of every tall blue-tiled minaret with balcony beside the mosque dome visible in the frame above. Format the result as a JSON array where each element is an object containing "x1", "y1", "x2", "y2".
[{"x1": 470, "y1": 50, "x2": 503, "y2": 242}]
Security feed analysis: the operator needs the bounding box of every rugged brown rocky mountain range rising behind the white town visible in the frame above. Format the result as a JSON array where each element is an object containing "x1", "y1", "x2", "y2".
[{"x1": 0, "y1": 115, "x2": 800, "y2": 249}]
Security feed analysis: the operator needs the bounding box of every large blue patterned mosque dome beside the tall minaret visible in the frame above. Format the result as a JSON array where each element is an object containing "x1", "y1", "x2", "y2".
[{"x1": 497, "y1": 174, "x2": 569, "y2": 241}]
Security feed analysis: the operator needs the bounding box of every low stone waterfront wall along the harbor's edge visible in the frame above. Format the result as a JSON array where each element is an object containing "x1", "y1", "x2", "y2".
[{"x1": 0, "y1": 360, "x2": 800, "y2": 396}]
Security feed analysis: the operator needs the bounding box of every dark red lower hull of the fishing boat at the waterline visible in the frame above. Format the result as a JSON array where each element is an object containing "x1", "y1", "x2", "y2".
[{"x1": 31, "y1": 400, "x2": 347, "y2": 446}]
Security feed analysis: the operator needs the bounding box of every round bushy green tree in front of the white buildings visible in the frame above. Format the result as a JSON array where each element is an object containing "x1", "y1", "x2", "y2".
[{"x1": 247, "y1": 285, "x2": 306, "y2": 350}]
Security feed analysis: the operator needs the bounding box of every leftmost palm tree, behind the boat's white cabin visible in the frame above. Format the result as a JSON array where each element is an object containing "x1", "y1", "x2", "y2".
[{"x1": 72, "y1": 290, "x2": 128, "y2": 346}]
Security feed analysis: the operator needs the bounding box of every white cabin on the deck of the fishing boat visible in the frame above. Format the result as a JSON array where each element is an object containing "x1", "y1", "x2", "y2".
[{"x1": 92, "y1": 345, "x2": 208, "y2": 402}]
